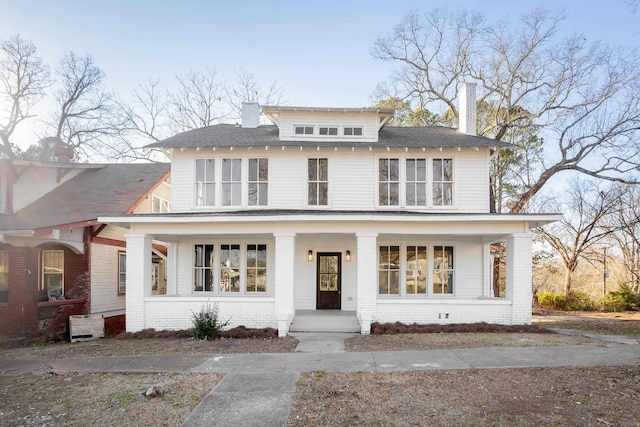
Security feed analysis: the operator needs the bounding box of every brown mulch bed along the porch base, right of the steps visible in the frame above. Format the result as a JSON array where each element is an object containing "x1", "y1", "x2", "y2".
[{"x1": 371, "y1": 322, "x2": 555, "y2": 335}]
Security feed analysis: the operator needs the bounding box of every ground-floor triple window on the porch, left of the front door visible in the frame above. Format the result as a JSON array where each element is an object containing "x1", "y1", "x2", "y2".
[{"x1": 193, "y1": 243, "x2": 267, "y2": 295}]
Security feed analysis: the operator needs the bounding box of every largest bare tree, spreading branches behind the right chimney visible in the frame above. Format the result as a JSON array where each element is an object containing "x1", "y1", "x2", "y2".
[{"x1": 372, "y1": 9, "x2": 640, "y2": 212}]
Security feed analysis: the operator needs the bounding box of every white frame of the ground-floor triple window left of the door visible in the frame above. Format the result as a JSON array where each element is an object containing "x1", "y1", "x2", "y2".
[{"x1": 191, "y1": 239, "x2": 273, "y2": 297}]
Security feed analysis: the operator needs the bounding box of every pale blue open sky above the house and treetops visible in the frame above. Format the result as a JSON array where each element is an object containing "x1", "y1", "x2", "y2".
[{"x1": 0, "y1": 0, "x2": 640, "y2": 107}]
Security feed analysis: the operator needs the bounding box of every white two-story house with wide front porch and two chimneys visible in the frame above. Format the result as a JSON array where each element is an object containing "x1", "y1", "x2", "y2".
[{"x1": 101, "y1": 86, "x2": 559, "y2": 336}]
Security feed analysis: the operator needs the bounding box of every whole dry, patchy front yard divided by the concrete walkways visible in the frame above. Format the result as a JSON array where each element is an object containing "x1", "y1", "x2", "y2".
[{"x1": 0, "y1": 312, "x2": 640, "y2": 426}]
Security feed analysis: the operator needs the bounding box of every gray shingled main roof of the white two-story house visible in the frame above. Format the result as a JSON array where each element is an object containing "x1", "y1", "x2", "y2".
[{"x1": 147, "y1": 124, "x2": 510, "y2": 148}]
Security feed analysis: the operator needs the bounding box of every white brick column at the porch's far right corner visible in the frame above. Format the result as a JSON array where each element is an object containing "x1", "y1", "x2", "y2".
[{"x1": 506, "y1": 233, "x2": 533, "y2": 325}]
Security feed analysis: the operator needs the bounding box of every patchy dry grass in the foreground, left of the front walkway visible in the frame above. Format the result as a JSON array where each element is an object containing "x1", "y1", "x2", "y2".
[{"x1": 0, "y1": 372, "x2": 222, "y2": 427}]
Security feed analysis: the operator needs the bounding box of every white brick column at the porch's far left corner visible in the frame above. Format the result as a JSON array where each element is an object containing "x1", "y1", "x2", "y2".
[{"x1": 125, "y1": 233, "x2": 151, "y2": 332}]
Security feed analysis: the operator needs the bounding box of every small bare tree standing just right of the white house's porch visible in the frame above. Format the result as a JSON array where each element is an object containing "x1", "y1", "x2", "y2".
[{"x1": 536, "y1": 180, "x2": 617, "y2": 297}]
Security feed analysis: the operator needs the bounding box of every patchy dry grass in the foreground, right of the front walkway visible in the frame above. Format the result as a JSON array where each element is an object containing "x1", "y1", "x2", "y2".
[{"x1": 288, "y1": 366, "x2": 640, "y2": 427}]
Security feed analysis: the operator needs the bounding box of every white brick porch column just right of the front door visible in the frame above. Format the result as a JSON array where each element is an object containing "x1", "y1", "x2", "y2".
[{"x1": 355, "y1": 233, "x2": 378, "y2": 335}]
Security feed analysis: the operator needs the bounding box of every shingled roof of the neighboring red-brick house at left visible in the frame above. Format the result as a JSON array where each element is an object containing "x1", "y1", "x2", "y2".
[{"x1": 0, "y1": 163, "x2": 171, "y2": 230}]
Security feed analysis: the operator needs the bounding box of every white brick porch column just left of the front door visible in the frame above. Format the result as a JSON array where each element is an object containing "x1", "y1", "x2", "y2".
[{"x1": 273, "y1": 233, "x2": 296, "y2": 337}]
